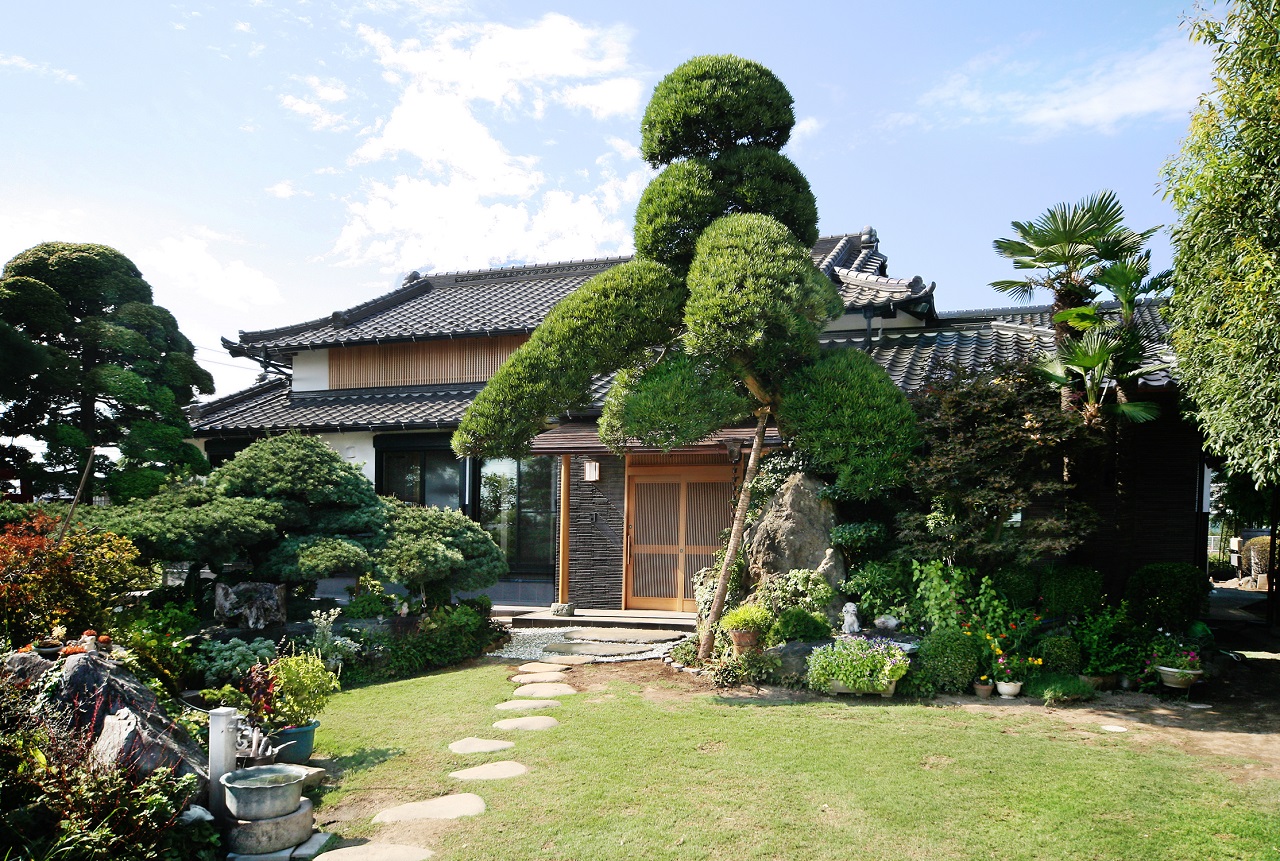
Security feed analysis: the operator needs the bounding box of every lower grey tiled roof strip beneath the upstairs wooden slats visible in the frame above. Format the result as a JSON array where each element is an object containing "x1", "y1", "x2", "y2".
[{"x1": 191, "y1": 377, "x2": 479, "y2": 436}]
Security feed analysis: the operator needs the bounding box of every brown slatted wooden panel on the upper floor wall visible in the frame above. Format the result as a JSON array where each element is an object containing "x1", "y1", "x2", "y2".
[{"x1": 329, "y1": 335, "x2": 529, "y2": 389}]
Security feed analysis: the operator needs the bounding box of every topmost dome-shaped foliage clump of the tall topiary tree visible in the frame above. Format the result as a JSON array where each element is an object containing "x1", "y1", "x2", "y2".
[{"x1": 640, "y1": 54, "x2": 796, "y2": 168}]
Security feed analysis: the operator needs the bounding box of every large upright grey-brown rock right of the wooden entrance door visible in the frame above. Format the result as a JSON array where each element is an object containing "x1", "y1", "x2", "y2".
[{"x1": 746, "y1": 472, "x2": 846, "y2": 612}]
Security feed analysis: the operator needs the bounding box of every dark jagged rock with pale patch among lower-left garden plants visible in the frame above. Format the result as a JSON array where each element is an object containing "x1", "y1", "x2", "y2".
[{"x1": 42, "y1": 652, "x2": 209, "y2": 797}]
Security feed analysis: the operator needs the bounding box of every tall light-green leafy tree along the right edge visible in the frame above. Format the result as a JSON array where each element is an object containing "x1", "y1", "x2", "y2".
[{"x1": 1165, "y1": 3, "x2": 1280, "y2": 487}]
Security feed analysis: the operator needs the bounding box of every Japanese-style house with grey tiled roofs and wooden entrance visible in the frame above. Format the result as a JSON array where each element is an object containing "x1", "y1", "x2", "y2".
[{"x1": 193, "y1": 228, "x2": 1207, "y2": 610}]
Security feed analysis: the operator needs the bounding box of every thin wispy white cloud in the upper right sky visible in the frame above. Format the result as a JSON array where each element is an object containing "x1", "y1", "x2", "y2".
[{"x1": 916, "y1": 33, "x2": 1213, "y2": 134}]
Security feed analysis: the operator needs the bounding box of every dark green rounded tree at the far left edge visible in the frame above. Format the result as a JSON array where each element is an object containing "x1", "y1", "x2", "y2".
[{"x1": 0, "y1": 242, "x2": 214, "y2": 500}]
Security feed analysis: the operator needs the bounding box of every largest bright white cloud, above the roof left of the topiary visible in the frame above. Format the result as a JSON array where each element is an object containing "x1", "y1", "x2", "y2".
[{"x1": 327, "y1": 14, "x2": 652, "y2": 271}]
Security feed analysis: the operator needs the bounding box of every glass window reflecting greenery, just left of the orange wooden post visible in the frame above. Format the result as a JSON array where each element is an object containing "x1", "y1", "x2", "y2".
[{"x1": 476, "y1": 457, "x2": 557, "y2": 571}]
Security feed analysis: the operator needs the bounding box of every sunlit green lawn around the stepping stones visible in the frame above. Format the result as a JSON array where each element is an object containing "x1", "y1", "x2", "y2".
[{"x1": 317, "y1": 664, "x2": 1280, "y2": 861}]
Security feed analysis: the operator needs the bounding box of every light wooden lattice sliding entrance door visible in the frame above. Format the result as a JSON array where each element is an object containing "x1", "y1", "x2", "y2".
[{"x1": 626, "y1": 464, "x2": 735, "y2": 613}]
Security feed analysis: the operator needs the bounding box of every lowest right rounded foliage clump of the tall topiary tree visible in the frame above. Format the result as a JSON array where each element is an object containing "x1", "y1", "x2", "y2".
[{"x1": 778, "y1": 349, "x2": 920, "y2": 500}]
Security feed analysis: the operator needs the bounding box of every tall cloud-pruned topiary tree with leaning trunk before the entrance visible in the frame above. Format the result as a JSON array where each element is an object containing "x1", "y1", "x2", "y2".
[{"x1": 453, "y1": 55, "x2": 914, "y2": 658}]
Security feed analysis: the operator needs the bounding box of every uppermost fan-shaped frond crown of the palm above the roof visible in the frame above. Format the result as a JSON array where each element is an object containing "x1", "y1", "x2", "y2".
[{"x1": 991, "y1": 191, "x2": 1158, "y2": 344}]
